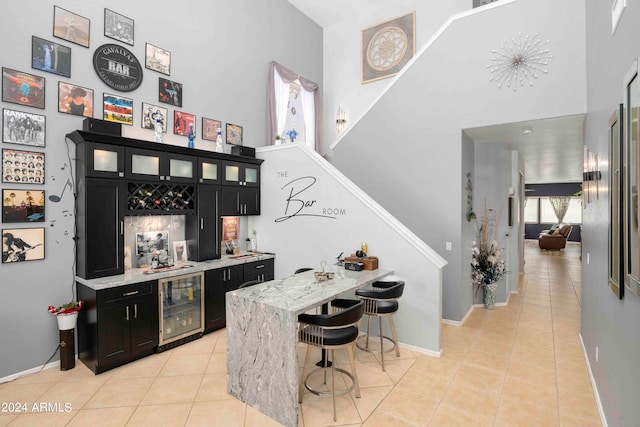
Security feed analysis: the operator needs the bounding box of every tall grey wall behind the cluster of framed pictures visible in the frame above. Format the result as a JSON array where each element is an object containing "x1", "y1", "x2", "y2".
[{"x1": 0, "y1": 0, "x2": 322, "y2": 378}]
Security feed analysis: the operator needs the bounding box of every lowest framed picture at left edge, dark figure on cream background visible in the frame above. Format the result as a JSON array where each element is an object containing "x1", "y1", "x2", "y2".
[{"x1": 2, "y1": 227, "x2": 44, "y2": 264}]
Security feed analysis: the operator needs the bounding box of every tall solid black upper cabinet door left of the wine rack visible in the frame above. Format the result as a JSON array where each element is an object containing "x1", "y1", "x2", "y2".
[{"x1": 78, "y1": 179, "x2": 126, "y2": 279}]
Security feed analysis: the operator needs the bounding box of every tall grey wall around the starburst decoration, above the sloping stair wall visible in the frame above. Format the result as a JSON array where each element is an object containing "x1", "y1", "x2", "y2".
[{"x1": 332, "y1": 0, "x2": 586, "y2": 320}]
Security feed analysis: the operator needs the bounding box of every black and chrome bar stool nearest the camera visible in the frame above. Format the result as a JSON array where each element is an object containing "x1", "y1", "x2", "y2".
[{"x1": 298, "y1": 299, "x2": 364, "y2": 421}]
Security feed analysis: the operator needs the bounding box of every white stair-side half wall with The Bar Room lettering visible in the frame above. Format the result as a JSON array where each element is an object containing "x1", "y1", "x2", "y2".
[{"x1": 249, "y1": 144, "x2": 446, "y2": 354}]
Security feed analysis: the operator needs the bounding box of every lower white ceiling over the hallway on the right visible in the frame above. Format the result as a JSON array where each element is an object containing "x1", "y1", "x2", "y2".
[{"x1": 465, "y1": 114, "x2": 584, "y2": 184}]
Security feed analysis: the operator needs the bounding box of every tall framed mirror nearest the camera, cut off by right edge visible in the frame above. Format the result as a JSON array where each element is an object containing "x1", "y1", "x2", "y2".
[{"x1": 622, "y1": 60, "x2": 640, "y2": 296}]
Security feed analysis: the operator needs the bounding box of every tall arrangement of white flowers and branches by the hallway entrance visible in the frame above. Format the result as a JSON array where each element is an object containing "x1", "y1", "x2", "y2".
[{"x1": 471, "y1": 205, "x2": 508, "y2": 300}]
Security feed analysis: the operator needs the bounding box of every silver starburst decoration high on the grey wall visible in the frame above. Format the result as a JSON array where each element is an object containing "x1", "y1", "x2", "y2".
[{"x1": 487, "y1": 33, "x2": 553, "y2": 91}]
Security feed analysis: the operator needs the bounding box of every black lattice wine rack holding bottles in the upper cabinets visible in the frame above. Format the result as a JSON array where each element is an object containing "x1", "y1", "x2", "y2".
[{"x1": 127, "y1": 183, "x2": 196, "y2": 215}]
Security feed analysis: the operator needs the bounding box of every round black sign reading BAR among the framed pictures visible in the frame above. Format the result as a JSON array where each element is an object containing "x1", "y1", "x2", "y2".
[{"x1": 93, "y1": 44, "x2": 142, "y2": 92}]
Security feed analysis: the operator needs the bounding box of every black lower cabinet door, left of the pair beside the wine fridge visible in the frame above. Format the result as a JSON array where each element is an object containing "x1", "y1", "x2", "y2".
[{"x1": 97, "y1": 304, "x2": 131, "y2": 365}]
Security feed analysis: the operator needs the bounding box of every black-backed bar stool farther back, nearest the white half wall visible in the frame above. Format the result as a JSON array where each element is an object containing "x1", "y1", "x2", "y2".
[{"x1": 356, "y1": 281, "x2": 404, "y2": 371}]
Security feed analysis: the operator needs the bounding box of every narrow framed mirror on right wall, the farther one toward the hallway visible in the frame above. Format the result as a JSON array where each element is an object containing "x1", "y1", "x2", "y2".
[{"x1": 608, "y1": 104, "x2": 624, "y2": 299}]
